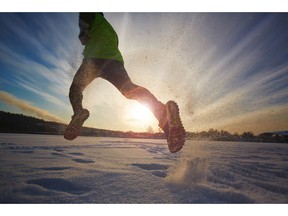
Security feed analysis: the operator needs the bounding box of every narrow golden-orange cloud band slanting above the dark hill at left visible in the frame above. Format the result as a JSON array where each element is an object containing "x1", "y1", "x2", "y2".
[{"x1": 0, "y1": 91, "x2": 65, "y2": 123}]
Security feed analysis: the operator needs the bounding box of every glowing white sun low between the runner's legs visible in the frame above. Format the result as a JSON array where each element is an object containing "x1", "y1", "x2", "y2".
[{"x1": 126, "y1": 102, "x2": 156, "y2": 131}]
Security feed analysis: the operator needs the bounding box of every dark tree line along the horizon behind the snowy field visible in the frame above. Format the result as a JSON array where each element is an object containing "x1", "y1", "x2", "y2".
[{"x1": 0, "y1": 111, "x2": 288, "y2": 143}]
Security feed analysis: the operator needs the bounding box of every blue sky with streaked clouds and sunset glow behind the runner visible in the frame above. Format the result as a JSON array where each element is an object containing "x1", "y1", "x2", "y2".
[{"x1": 0, "y1": 12, "x2": 288, "y2": 134}]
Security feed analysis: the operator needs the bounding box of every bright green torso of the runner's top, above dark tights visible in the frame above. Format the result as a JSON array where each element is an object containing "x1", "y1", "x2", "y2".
[{"x1": 83, "y1": 14, "x2": 124, "y2": 64}]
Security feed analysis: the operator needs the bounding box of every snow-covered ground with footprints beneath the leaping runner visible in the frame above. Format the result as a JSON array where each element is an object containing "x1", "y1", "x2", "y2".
[{"x1": 0, "y1": 134, "x2": 288, "y2": 203}]
